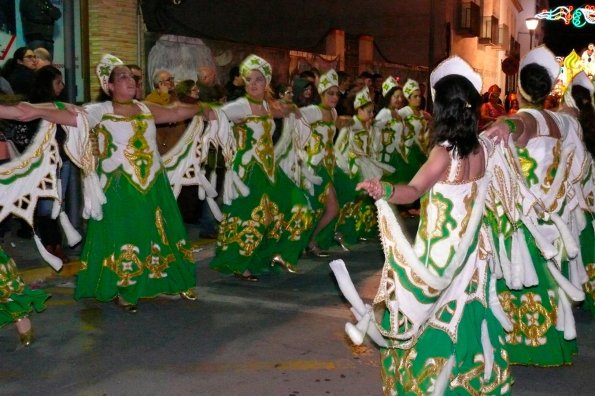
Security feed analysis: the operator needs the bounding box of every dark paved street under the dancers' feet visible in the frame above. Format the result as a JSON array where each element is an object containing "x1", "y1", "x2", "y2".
[{"x1": 0, "y1": 221, "x2": 595, "y2": 396}]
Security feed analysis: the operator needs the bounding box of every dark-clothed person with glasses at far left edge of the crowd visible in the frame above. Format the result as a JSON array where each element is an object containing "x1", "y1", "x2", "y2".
[{"x1": 2, "y1": 47, "x2": 37, "y2": 99}]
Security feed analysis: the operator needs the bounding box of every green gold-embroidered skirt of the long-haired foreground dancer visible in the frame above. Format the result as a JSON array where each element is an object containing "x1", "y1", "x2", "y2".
[{"x1": 380, "y1": 292, "x2": 512, "y2": 395}]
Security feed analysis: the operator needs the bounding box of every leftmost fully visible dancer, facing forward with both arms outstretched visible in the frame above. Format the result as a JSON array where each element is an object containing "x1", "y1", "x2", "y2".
[{"x1": 14, "y1": 55, "x2": 211, "y2": 312}]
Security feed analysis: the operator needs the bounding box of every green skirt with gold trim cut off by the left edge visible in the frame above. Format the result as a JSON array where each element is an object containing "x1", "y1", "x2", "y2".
[{"x1": 0, "y1": 248, "x2": 49, "y2": 327}]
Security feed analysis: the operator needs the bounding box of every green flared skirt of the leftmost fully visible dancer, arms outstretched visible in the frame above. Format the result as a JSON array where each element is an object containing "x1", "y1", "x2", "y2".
[{"x1": 74, "y1": 170, "x2": 196, "y2": 304}]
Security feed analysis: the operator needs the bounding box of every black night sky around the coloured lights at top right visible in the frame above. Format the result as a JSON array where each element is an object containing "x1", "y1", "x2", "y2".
[{"x1": 540, "y1": 0, "x2": 595, "y2": 56}]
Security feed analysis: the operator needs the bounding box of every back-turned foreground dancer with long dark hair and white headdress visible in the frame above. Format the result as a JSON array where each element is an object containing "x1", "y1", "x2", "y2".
[{"x1": 358, "y1": 57, "x2": 517, "y2": 395}]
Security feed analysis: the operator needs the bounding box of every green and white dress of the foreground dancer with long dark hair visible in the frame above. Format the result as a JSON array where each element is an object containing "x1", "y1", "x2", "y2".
[{"x1": 373, "y1": 139, "x2": 516, "y2": 395}]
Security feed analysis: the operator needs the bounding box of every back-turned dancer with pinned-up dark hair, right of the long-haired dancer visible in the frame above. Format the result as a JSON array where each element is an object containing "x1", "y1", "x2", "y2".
[{"x1": 487, "y1": 46, "x2": 586, "y2": 367}]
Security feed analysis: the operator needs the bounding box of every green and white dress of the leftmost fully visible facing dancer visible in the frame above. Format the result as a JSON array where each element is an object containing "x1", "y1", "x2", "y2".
[{"x1": 66, "y1": 102, "x2": 196, "y2": 304}]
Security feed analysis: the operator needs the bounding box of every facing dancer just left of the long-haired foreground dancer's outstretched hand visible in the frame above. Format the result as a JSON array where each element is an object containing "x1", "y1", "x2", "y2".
[{"x1": 335, "y1": 88, "x2": 394, "y2": 244}]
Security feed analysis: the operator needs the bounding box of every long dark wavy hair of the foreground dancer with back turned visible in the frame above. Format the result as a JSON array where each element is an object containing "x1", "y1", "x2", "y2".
[{"x1": 431, "y1": 75, "x2": 481, "y2": 158}]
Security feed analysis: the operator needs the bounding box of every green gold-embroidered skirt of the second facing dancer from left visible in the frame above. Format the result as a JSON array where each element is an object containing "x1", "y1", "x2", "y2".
[{"x1": 209, "y1": 164, "x2": 313, "y2": 275}]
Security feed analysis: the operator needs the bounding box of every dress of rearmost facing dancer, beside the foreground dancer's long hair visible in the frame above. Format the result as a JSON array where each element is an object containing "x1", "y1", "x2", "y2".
[{"x1": 399, "y1": 106, "x2": 429, "y2": 183}]
